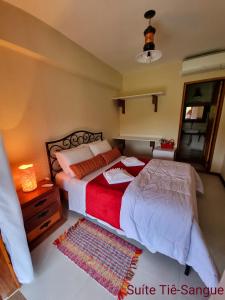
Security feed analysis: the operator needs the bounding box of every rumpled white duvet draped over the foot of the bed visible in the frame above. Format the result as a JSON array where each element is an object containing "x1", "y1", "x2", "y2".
[{"x1": 120, "y1": 159, "x2": 218, "y2": 286}]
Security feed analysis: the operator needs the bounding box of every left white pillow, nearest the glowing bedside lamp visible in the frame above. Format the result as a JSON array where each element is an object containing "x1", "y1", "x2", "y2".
[{"x1": 55, "y1": 144, "x2": 94, "y2": 177}]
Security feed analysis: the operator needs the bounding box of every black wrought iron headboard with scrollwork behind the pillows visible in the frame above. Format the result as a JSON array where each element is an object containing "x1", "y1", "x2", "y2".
[{"x1": 45, "y1": 130, "x2": 102, "y2": 181}]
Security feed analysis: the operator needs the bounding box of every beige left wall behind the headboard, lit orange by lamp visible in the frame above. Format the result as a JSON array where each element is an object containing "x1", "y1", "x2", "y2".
[{"x1": 0, "y1": 2, "x2": 122, "y2": 185}]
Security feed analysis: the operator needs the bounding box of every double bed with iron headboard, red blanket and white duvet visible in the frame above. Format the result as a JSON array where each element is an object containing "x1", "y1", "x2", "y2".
[{"x1": 46, "y1": 131, "x2": 218, "y2": 287}]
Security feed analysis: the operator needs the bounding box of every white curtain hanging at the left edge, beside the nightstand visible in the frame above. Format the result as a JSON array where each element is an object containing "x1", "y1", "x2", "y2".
[{"x1": 0, "y1": 133, "x2": 33, "y2": 283}]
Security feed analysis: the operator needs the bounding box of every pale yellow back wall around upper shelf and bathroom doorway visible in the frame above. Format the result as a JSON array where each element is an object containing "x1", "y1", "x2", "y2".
[{"x1": 120, "y1": 62, "x2": 225, "y2": 172}]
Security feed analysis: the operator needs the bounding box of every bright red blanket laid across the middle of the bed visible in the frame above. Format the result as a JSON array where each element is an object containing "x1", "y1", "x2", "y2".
[{"x1": 86, "y1": 159, "x2": 148, "y2": 229}]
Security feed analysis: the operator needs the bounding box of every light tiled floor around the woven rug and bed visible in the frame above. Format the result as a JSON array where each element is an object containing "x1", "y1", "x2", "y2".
[{"x1": 21, "y1": 174, "x2": 225, "y2": 300}]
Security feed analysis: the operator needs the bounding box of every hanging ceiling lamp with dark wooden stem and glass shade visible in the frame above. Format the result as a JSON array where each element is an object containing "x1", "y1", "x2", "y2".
[{"x1": 136, "y1": 10, "x2": 162, "y2": 64}]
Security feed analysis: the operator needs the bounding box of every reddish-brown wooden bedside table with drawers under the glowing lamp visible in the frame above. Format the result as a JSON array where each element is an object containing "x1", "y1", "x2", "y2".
[{"x1": 17, "y1": 181, "x2": 62, "y2": 248}]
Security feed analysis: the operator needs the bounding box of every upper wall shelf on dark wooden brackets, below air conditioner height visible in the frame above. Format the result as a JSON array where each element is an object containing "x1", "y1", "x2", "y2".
[{"x1": 112, "y1": 92, "x2": 164, "y2": 114}]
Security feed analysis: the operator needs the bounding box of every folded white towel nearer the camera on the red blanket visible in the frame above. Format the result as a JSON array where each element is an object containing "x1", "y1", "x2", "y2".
[{"x1": 103, "y1": 168, "x2": 134, "y2": 184}]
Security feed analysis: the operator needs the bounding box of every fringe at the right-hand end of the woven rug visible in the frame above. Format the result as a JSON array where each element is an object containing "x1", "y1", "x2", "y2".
[{"x1": 118, "y1": 249, "x2": 142, "y2": 300}]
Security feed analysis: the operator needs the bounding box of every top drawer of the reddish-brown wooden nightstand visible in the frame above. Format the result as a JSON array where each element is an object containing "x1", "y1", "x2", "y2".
[{"x1": 22, "y1": 191, "x2": 58, "y2": 221}]
